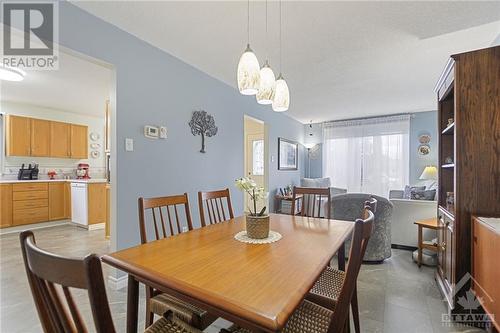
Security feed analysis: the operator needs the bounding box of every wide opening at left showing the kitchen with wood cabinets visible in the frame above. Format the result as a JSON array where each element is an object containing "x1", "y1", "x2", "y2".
[{"x1": 0, "y1": 40, "x2": 116, "y2": 252}]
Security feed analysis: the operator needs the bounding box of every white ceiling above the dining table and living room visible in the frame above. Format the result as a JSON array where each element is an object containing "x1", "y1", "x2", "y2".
[{"x1": 75, "y1": 1, "x2": 500, "y2": 122}]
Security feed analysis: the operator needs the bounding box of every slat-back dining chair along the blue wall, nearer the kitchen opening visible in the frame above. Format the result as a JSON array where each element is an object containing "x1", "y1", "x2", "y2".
[{"x1": 139, "y1": 193, "x2": 217, "y2": 330}]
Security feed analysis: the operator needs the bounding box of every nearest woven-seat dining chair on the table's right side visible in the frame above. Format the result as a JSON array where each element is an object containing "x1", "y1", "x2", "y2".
[{"x1": 221, "y1": 204, "x2": 374, "y2": 333}]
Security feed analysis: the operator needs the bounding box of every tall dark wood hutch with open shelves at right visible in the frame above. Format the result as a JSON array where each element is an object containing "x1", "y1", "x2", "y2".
[{"x1": 435, "y1": 46, "x2": 500, "y2": 313}]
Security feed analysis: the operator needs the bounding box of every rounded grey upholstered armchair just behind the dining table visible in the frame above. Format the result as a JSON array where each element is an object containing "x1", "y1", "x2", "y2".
[{"x1": 331, "y1": 193, "x2": 393, "y2": 262}]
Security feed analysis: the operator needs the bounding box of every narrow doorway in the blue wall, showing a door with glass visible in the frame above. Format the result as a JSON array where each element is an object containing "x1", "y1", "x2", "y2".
[{"x1": 243, "y1": 115, "x2": 269, "y2": 212}]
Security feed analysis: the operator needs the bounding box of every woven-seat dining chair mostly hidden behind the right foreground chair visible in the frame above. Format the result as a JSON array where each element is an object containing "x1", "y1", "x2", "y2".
[{"x1": 306, "y1": 198, "x2": 377, "y2": 333}]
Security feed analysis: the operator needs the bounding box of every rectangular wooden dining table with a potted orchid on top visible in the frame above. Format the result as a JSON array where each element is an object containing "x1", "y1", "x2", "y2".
[{"x1": 102, "y1": 214, "x2": 354, "y2": 333}]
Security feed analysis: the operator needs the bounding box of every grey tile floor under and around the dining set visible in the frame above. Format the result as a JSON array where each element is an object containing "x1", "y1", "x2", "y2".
[{"x1": 0, "y1": 225, "x2": 482, "y2": 333}]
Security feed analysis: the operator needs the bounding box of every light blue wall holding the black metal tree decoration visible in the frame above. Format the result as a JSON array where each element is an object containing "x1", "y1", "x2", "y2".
[{"x1": 54, "y1": 2, "x2": 304, "y2": 249}]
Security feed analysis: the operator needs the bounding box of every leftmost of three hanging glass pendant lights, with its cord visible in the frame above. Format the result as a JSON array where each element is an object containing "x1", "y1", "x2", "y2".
[{"x1": 237, "y1": 0, "x2": 260, "y2": 95}]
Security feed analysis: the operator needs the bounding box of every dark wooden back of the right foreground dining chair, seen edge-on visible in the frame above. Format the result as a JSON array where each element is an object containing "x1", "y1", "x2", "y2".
[{"x1": 328, "y1": 205, "x2": 374, "y2": 333}]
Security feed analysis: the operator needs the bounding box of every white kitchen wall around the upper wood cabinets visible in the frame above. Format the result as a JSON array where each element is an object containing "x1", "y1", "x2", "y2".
[{"x1": 1, "y1": 101, "x2": 105, "y2": 178}]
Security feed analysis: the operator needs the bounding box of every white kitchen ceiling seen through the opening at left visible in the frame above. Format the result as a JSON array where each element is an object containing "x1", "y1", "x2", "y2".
[{"x1": 0, "y1": 38, "x2": 112, "y2": 117}]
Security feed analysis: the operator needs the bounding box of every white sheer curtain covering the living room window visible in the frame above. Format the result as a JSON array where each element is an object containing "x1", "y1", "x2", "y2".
[{"x1": 323, "y1": 115, "x2": 410, "y2": 197}]
